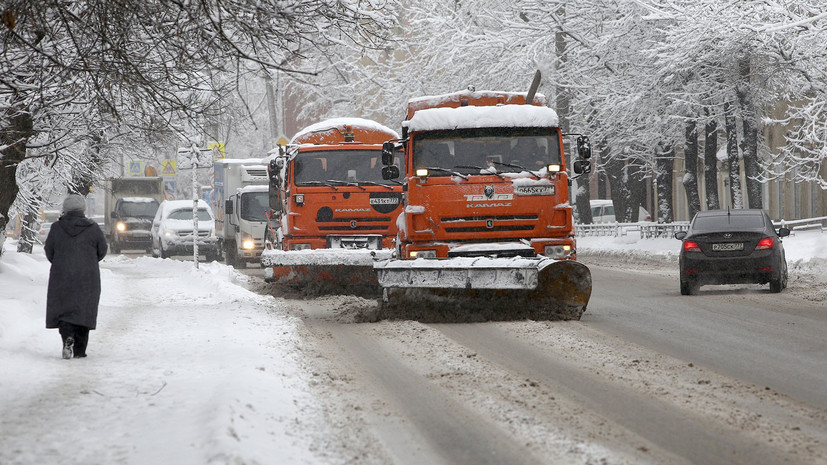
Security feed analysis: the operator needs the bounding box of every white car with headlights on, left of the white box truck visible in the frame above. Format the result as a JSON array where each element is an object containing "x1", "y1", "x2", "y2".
[{"x1": 151, "y1": 200, "x2": 219, "y2": 261}]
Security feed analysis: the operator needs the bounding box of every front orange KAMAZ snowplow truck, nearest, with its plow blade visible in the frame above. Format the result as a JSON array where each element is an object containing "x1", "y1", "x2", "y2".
[{"x1": 375, "y1": 84, "x2": 591, "y2": 319}]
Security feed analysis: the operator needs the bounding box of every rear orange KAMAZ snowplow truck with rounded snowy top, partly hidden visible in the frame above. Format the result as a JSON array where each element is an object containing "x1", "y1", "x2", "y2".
[{"x1": 261, "y1": 118, "x2": 402, "y2": 293}]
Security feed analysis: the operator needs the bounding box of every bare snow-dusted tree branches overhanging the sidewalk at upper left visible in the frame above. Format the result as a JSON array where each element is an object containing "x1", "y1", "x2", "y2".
[{"x1": 0, "y1": 0, "x2": 393, "y2": 250}]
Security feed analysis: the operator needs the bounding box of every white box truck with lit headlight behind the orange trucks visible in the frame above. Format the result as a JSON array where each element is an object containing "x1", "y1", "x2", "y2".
[{"x1": 211, "y1": 158, "x2": 270, "y2": 266}]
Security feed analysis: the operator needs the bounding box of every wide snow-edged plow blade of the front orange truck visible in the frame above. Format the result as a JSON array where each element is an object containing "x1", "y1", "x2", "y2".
[{"x1": 374, "y1": 258, "x2": 592, "y2": 323}]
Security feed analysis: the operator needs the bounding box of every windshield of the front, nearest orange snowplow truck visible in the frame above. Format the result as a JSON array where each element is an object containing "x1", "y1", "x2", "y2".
[{"x1": 413, "y1": 128, "x2": 561, "y2": 176}]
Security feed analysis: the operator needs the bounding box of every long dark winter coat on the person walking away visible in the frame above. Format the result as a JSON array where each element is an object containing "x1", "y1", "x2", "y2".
[{"x1": 44, "y1": 211, "x2": 106, "y2": 329}]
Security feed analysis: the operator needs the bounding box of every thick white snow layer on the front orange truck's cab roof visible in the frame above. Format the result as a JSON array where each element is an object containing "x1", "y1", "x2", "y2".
[{"x1": 403, "y1": 105, "x2": 559, "y2": 131}]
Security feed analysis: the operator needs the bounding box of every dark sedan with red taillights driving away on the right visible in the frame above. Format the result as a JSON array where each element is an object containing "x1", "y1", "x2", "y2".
[{"x1": 675, "y1": 209, "x2": 790, "y2": 295}]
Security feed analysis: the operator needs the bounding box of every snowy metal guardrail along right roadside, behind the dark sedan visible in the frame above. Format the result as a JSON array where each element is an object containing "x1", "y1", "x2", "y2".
[{"x1": 574, "y1": 216, "x2": 827, "y2": 239}]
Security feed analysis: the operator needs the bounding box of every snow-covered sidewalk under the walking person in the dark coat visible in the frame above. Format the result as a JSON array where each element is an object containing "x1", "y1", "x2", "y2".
[{"x1": 0, "y1": 250, "x2": 325, "y2": 465}]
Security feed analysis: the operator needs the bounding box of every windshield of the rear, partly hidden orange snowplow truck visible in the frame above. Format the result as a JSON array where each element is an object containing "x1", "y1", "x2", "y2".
[{"x1": 293, "y1": 149, "x2": 403, "y2": 186}]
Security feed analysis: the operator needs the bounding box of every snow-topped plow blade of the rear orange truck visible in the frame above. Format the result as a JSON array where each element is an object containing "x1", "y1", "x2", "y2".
[{"x1": 261, "y1": 249, "x2": 390, "y2": 296}]
